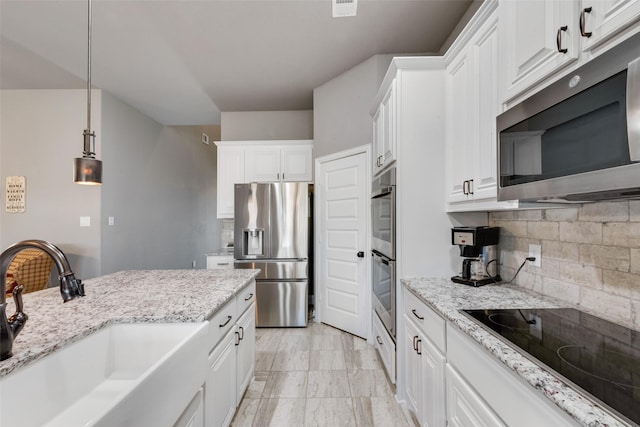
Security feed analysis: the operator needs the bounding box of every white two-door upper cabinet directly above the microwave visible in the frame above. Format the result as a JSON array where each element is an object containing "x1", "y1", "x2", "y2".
[{"x1": 500, "y1": 0, "x2": 640, "y2": 107}]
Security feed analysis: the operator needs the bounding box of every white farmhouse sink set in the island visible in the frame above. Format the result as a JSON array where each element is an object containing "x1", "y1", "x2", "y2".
[{"x1": 0, "y1": 323, "x2": 207, "y2": 427}]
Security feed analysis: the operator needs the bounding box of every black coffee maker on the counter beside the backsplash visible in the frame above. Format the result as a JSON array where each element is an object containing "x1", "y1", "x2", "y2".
[{"x1": 451, "y1": 226, "x2": 502, "y2": 287}]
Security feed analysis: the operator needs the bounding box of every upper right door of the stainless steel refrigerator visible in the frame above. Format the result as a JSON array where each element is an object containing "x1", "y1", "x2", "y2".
[{"x1": 269, "y1": 182, "x2": 309, "y2": 259}]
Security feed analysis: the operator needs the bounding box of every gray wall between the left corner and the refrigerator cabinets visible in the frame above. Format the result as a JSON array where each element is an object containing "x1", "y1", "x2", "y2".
[{"x1": 102, "y1": 94, "x2": 220, "y2": 274}]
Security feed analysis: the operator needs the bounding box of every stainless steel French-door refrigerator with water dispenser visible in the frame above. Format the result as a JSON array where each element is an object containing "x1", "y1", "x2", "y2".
[{"x1": 234, "y1": 182, "x2": 312, "y2": 327}]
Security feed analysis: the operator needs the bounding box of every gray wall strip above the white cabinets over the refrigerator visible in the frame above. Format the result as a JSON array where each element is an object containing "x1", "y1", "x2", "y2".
[{"x1": 220, "y1": 111, "x2": 313, "y2": 141}]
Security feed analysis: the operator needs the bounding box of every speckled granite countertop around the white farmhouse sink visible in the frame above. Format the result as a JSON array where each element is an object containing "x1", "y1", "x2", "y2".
[{"x1": 0, "y1": 269, "x2": 259, "y2": 378}]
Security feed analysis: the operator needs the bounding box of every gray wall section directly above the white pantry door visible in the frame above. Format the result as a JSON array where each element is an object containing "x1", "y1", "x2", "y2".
[{"x1": 313, "y1": 55, "x2": 393, "y2": 157}]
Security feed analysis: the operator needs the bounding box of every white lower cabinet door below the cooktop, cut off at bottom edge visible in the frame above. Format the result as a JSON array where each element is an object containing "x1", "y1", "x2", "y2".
[{"x1": 447, "y1": 365, "x2": 505, "y2": 427}]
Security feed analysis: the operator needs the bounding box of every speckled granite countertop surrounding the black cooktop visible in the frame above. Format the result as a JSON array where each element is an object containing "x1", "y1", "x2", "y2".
[{"x1": 402, "y1": 278, "x2": 628, "y2": 426}]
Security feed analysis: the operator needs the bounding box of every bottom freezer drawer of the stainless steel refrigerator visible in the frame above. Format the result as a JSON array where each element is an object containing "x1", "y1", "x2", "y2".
[{"x1": 256, "y1": 280, "x2": 309, "y2": 327}]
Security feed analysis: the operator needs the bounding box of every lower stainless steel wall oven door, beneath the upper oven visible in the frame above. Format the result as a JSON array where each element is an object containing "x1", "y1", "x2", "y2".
[{"x1": 371, "y1": 251, "x2": 396, "y2": 342}]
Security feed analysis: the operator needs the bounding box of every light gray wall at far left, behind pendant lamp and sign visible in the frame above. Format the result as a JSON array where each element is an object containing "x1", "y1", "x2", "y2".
[{"x1": 0, "y1": 90, "x2": 102, "y2": 278}]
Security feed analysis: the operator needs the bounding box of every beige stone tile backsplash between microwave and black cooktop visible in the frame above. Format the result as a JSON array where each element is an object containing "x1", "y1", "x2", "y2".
[{"x1": 489, "y1": 201, "x2": 640, "y2": 329}]
